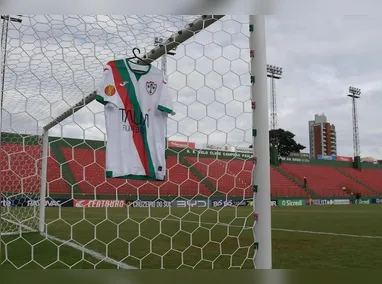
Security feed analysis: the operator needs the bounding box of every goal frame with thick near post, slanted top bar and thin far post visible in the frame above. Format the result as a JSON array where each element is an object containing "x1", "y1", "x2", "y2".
[{"x1": 0, "y1": 15, "x2": 272, "y2": 269}]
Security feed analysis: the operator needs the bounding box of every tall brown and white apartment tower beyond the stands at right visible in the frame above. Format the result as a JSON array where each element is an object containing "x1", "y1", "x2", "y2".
[{"x1": 309, "y1": 114, "x2": 337, "y2": 159}]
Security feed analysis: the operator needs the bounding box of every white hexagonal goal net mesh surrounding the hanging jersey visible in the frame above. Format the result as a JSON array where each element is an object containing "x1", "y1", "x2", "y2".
[{"x1": 0, "y1": 16, "x2": 255, "y2": 268}]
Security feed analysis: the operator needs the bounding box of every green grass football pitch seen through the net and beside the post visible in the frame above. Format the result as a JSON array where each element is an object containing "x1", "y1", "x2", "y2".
[{"x1": 0, "y1": 205, "x2": 382, "y2": 269}]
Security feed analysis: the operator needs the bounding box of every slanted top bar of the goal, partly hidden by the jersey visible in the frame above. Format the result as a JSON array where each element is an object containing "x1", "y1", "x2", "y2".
[{"x1": 44, "y1": 15, "x2": 224, "y2": 130}]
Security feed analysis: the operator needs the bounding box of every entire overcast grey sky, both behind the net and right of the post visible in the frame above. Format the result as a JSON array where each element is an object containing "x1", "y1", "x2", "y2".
[{"x1": 3, "y1": 16, "x2": 382, "y2": 158}]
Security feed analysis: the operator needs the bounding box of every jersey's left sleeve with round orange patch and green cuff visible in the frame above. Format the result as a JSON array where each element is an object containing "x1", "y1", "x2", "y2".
[{"x1": 96, "y1": 65, "x2": 117, "y2": 105}]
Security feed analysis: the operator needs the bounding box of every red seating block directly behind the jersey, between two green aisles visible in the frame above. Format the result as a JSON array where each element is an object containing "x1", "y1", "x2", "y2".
[{"x1": 61, "y1": 148, "x2": 211, "y2": 196}]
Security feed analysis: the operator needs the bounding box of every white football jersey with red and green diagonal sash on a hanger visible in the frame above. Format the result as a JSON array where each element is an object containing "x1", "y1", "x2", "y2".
[{"x1": 96, "y1": 59, "x2": 174, "y2": 180}]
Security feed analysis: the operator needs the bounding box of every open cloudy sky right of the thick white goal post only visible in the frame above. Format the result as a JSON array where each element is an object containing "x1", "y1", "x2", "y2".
[{"x1": 267, "y1": 16, "x2": 382, "y2": 158}]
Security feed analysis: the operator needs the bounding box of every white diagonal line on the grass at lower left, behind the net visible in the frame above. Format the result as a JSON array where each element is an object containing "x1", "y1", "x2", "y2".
[{"x1": 3, "y1": 218, "x2": 137, "y2": 269}]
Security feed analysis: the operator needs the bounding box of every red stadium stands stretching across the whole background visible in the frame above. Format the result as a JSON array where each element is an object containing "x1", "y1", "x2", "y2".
[{"x1": 0, "y1": 141, "x2": 382, "y2": 197}]
